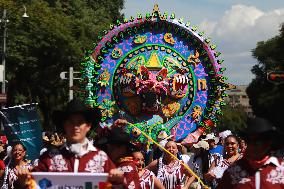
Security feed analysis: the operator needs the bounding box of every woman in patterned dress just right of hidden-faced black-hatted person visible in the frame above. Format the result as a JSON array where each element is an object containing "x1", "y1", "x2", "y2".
[{"x1": 132, "y1": 151, "x2": 165, "y2": 189}]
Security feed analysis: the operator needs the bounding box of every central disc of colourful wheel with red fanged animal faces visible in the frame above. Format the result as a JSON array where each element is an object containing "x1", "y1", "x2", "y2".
[{"x1": 114, "y1": 45, "x2": 194, "y2": 118}]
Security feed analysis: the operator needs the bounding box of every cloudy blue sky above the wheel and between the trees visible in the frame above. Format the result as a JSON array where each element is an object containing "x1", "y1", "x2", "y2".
[{"x1": 122, "y1": 0, "x2": 284, "y2": 85}]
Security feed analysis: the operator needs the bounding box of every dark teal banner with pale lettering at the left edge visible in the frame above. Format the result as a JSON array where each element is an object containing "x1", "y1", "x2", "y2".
[{"x1": 0, "y1": 104, "x2": 43, "y2": 160}]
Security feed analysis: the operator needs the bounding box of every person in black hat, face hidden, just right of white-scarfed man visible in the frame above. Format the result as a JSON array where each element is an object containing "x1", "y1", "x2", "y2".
[{"x1": 99, "y1": 119, "x2": 141, "y2": 189}]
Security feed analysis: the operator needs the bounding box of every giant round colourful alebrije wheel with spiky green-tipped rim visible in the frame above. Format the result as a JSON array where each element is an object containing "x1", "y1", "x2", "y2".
[{"x1": 81, "y1": 5, "x2": 228, "y2": 142}]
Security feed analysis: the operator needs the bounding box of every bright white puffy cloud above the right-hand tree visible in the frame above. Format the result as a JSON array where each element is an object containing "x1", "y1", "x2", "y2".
[{"x1": 200, "y1": 4, "x2": 284, "y2": 50}]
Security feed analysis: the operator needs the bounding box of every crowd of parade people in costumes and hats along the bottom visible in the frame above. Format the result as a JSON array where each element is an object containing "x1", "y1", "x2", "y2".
[{"x1": 0, "y1": 99, "x2": 284, "y2": 189}]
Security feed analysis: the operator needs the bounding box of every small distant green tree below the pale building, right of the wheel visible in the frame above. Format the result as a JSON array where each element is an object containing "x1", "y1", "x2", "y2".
[{"x1": 217, "y1": 104, "x2": 247, "y2": 134}]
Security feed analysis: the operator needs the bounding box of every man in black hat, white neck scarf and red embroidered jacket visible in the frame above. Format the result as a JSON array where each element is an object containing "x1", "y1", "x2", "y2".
[{"x1": 34, "y1": 99, "x2": 115, "y2": 173}]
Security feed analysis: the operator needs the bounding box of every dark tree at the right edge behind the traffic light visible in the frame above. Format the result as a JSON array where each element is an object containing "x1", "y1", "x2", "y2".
[{"x1": 247, "y1": 25, "x2": 284, "y2": 130}]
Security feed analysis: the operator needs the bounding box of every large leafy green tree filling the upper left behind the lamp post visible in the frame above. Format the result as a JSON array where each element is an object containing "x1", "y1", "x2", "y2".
[{"x1": 0, "y1": 0, "x2": 124, "y2": 128}]
